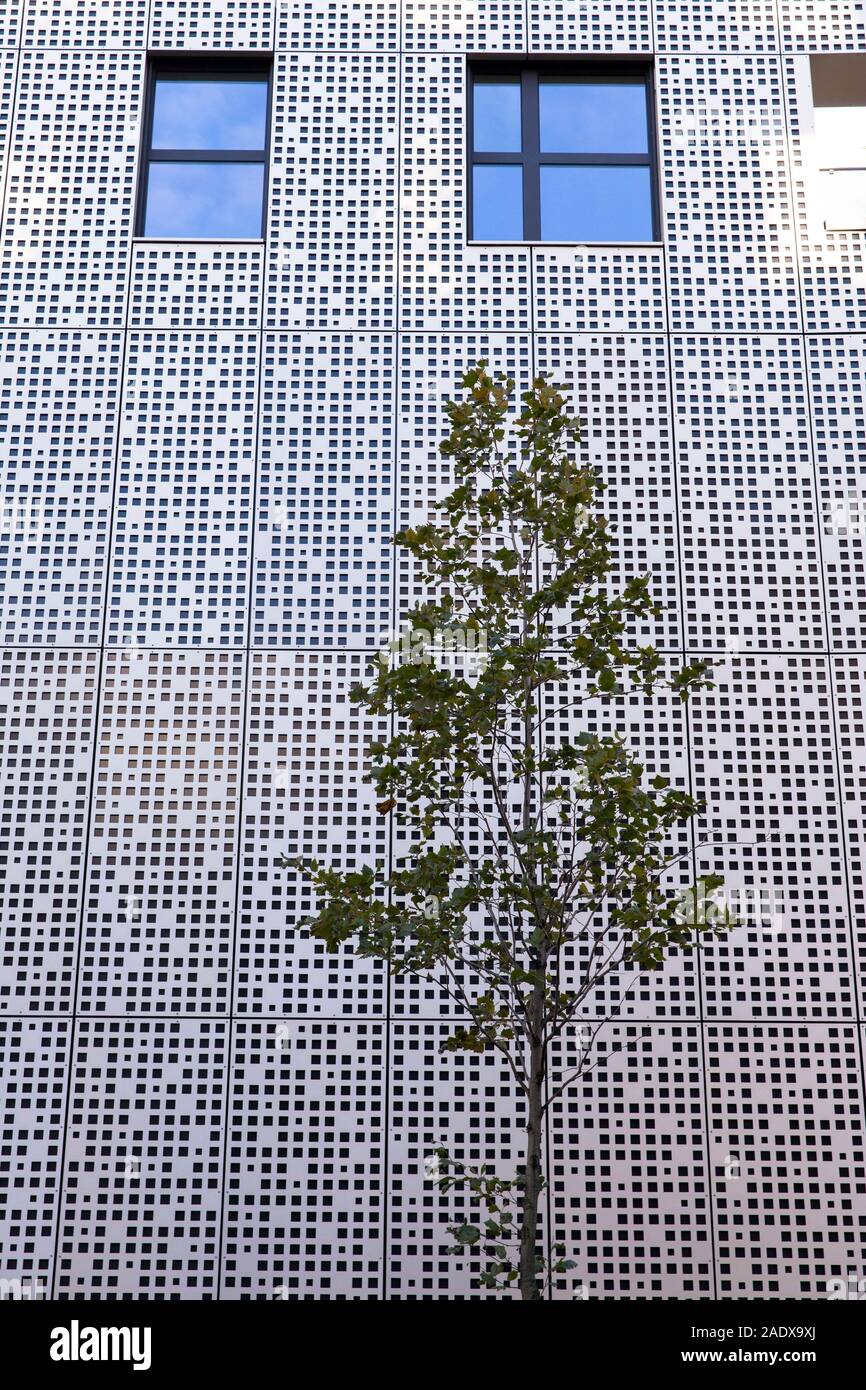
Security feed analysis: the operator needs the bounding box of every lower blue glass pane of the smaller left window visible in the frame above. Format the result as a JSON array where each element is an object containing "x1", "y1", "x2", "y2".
[{"x1": 145, "y1": 163, "x2": 264, "y2": 236}]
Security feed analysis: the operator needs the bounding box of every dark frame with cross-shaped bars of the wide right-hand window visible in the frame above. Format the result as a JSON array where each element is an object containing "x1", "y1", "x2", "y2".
[{"x1": 466, "y1": 57, "x2": 662, "y2": 246}]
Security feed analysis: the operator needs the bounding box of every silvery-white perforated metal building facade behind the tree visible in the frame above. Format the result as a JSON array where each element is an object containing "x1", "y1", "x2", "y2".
[{"x1": 0, "y1": 0, "x2": 866, "y2": 1300}]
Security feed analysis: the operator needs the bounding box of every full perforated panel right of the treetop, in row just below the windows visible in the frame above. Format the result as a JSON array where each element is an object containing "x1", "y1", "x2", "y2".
[{"x1": 671, "y1": 335, "x2": 824, "y2": 652}]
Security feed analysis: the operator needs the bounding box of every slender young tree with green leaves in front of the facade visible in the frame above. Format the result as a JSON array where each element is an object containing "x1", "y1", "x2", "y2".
[{"x1": 282, "y1": 363, "x2": 731, "y2": 1300}]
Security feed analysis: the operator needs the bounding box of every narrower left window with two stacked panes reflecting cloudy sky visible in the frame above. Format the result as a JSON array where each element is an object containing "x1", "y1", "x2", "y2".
[{"x1": 139, "y1": 58, "x2": 270, "y2": 239}]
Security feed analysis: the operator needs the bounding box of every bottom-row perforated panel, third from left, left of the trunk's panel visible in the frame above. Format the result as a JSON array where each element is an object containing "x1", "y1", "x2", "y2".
[{"x1": 222, "y1": 1019, "x2": 386, "y2": 1300}]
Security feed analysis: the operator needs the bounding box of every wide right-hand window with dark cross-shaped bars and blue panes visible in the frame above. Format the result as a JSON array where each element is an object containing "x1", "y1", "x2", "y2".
[{"x1": 468, "y1": 63, "x2": 656, "y2": 242}]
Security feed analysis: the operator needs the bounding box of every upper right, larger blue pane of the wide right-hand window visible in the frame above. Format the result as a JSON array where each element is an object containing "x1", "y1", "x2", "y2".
[{"x1": 538, "y1": 81, "x2": 648, "y2": 154}]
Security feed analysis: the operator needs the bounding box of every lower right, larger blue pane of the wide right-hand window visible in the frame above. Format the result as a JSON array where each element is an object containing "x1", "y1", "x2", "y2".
[{"x1": 541, "y1": 164, "x2": 652, "y2": 242}]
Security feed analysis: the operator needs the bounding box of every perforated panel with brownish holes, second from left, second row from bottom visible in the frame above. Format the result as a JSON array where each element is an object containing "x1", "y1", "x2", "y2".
[{"x1": 78, "y1": 646, "x2": 245, "y2": 1013}]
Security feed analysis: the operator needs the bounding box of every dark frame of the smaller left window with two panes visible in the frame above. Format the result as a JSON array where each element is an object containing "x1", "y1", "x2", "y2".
[{"x1": 135, "y1": 53, "x2": 274, "y2": 242}]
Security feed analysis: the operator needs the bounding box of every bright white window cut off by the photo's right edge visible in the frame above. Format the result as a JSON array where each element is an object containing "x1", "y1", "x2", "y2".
[{"x1": 810, "y1": 53, "x2": 866, "y2": 232}]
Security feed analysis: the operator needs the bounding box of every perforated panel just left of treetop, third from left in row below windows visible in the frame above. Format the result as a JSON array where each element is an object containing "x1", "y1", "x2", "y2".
[{"x1": 253, "y1": 334, "x2": 396, "y2": 649}]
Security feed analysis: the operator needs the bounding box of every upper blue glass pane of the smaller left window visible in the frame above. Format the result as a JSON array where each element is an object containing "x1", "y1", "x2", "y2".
[{"x1": 153, "y1": 78, "x2": 268, "y2": 150}]
